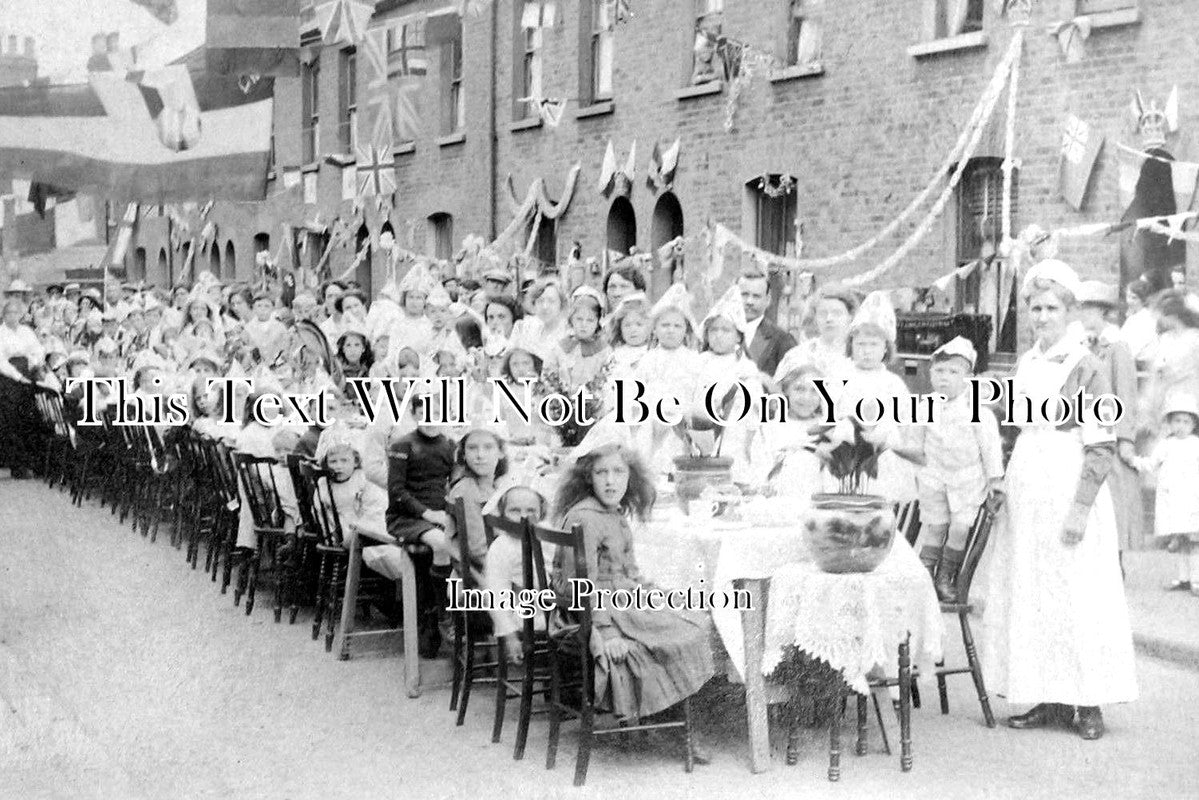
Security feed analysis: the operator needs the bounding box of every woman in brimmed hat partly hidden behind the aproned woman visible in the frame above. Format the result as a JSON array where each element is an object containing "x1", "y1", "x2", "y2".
[{"x1": 1072, "y1": 281, "x2": 1144, "y2": 554}]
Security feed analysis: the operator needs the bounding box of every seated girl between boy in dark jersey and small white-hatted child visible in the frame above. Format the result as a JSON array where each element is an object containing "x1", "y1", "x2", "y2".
[{"x1": 446, "y1": 428, "x2": 508, "y2": 581}]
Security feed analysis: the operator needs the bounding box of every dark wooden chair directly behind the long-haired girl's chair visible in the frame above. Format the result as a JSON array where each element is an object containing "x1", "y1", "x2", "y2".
[{"x1": 483, "y1": 515, "x2": 549, "y2": 760}]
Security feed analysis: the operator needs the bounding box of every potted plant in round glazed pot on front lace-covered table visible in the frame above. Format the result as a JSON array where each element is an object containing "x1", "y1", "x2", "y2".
[{"x1": 803, "y1": 419, "x2": 896, "y2": 572}]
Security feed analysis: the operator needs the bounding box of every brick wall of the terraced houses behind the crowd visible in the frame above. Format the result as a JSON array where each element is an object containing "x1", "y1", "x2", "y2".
[{"x1": 131, "y1": 0, "x2": 1199, "y2": 326}]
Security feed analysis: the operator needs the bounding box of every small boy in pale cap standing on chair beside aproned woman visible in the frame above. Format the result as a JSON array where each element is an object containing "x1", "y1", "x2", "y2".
[{"x1": 916, "y1": 336, "x2": 1004, "y2": 602}]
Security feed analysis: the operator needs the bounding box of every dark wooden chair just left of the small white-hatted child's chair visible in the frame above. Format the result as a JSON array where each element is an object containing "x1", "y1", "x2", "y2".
[{"x1": 446, "y1": 498, "x2": 500, "y2": 726}]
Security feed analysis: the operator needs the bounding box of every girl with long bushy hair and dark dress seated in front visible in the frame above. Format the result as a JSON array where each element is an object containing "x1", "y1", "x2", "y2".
[{"x1": 553, "y1": 431, "x2": 715, "y2": 720}]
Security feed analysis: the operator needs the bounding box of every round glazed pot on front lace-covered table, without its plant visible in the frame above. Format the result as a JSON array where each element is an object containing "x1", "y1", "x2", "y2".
[{"x1": 803, "y1": 494, "x2": 896, "y2": 573}]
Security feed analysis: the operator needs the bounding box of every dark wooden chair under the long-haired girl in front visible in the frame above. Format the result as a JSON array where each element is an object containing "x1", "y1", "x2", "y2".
[{"x1": 532, "y1": 525, "x2": 694, "y2": 786}]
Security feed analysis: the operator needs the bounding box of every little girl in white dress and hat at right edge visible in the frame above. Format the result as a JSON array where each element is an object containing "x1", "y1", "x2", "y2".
[{"x1": 1135, "y1": 395, "x2": 1199, "y2": 596}]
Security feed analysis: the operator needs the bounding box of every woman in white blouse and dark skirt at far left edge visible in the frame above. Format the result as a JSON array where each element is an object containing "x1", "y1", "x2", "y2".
[{"x1": 0, "y1": 295, "x2": 46, "y2": 479}]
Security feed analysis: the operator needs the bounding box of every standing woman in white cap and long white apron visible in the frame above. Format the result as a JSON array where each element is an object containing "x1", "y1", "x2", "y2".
[{"x1": 980, "y1": 260, "x2": 1137, "y2": 740}]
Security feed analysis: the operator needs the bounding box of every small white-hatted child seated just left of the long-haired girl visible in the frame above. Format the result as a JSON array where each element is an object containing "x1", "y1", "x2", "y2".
[{"x1": 483, "y1": 483, "x2": 554, "y2": 663}]
